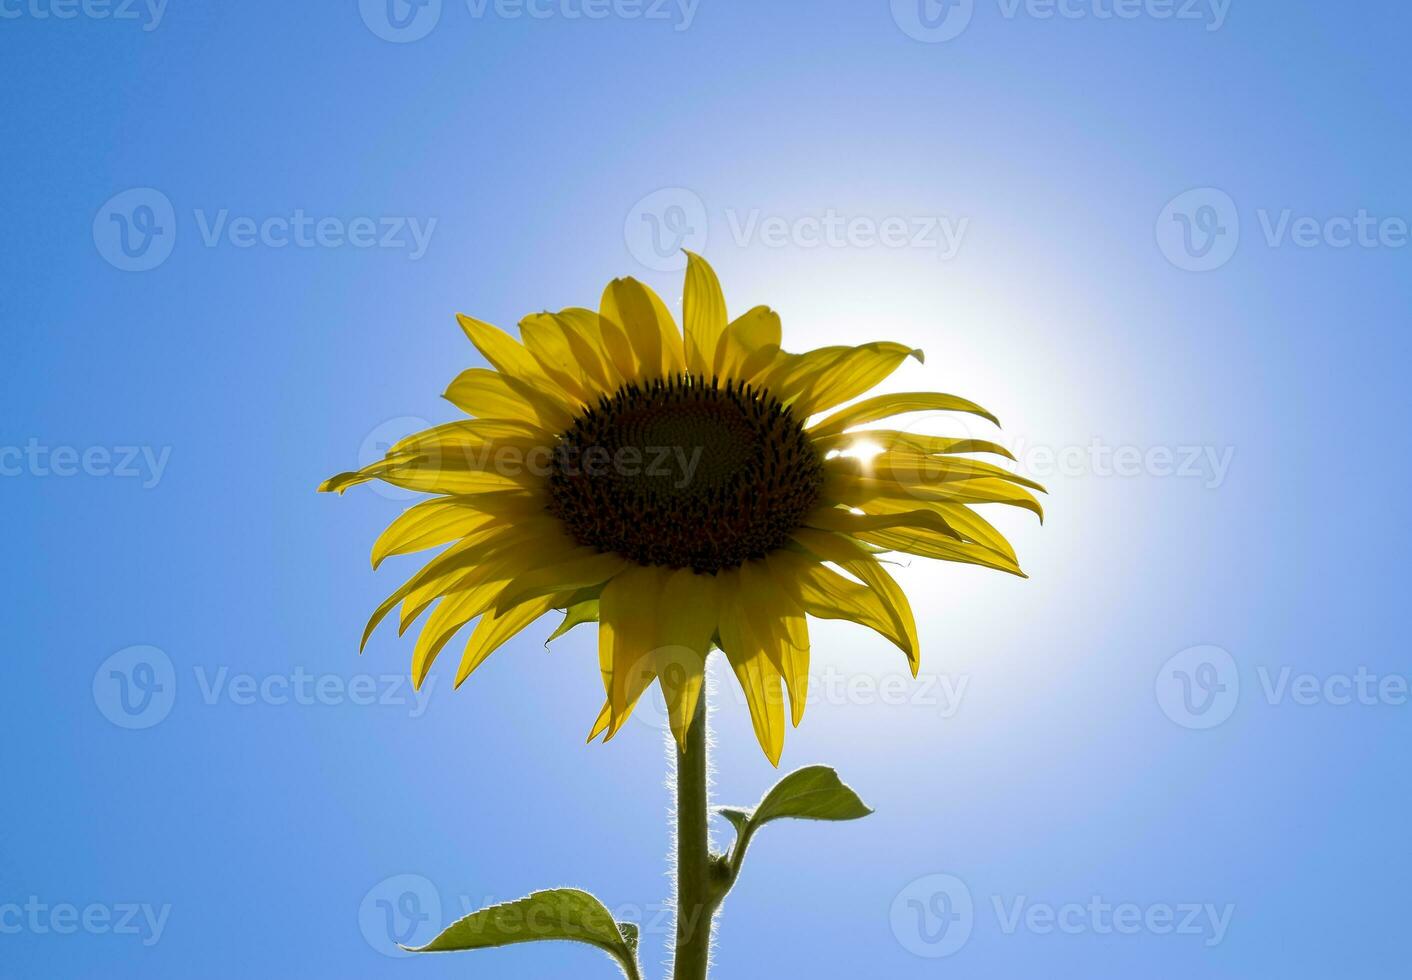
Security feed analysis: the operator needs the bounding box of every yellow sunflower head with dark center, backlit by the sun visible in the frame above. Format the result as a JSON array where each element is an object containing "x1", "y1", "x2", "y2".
[{"x1": 319, "y1": 254, "x2": 1042, "y2": 765}]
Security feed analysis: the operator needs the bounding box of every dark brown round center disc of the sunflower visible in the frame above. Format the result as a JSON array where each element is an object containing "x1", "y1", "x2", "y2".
[{"x1": 549, "y1": 374, "x2": 823, "y2": 573}]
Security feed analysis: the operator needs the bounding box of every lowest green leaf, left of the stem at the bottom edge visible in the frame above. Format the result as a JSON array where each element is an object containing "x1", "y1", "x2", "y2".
[{"x1": 412, "y1": 888, "x2": 638, "y2": 977}]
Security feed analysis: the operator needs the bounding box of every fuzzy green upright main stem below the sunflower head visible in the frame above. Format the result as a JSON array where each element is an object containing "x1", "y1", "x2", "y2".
[{"x1": 672, "y1": 691, "x2": 719, "y2": 980}]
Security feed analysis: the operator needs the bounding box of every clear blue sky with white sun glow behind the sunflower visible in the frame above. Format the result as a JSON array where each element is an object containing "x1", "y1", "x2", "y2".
[{"x1": 0, "y1": 0, "x2": 1412, "y2": 979}]
